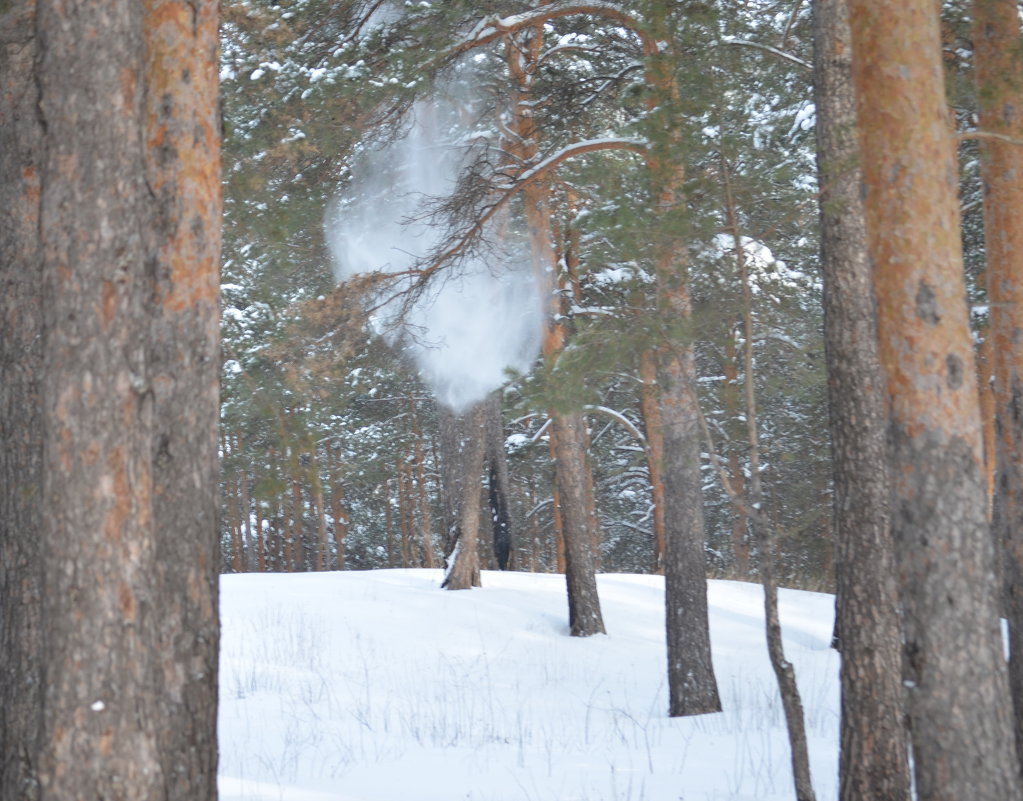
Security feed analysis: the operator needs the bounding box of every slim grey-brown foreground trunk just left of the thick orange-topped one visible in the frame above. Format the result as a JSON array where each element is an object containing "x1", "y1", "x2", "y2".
[{"x1": 813, "y1": 0, "x2": 909, "y2": 801}]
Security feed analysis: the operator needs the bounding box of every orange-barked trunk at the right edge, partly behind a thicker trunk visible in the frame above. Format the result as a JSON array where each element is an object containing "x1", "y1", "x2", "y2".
[{"x1": 973, "y1": 0, "x2": 1023, "y2": 759}]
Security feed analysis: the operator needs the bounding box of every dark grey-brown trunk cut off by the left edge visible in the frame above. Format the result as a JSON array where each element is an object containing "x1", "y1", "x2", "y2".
[{"x1": 0, "y1": 0, "x2": 44, "y2": 801}]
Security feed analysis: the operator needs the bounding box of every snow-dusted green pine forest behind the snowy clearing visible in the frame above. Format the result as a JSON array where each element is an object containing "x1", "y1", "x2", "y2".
[{"x1": 221, "y1": 0, "x2": 863, "y2": 589}]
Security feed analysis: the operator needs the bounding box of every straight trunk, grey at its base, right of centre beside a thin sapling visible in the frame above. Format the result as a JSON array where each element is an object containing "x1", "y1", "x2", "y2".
[{"x1": 646, "y1": 3, "x2": 721, "y2": 717}]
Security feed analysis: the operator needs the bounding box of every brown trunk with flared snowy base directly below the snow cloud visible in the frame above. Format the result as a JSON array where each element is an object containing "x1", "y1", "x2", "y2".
[{"x1": 438, "y1": 403, "x2": 486, "y2": 589}]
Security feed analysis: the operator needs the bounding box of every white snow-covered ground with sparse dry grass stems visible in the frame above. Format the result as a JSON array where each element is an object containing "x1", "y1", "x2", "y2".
[{"x1": 220, "y1": 570, "x2": 838, "y2": 801}]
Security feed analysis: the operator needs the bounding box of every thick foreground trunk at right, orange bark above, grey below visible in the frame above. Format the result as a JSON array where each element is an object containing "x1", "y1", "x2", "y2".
[{"x1": 849, "y1": 0, "x2": 1021, "y2": 801}]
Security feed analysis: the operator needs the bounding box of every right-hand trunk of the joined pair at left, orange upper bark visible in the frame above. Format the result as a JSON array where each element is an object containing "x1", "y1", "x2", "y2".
[{"x1": 142, "y1": 0, "x2": 222, "y2": 789}]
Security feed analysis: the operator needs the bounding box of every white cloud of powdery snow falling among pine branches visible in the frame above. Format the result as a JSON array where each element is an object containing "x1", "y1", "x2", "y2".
[{"x1": 324, "y1": 101, "x2": 543, "y2": 412}]
